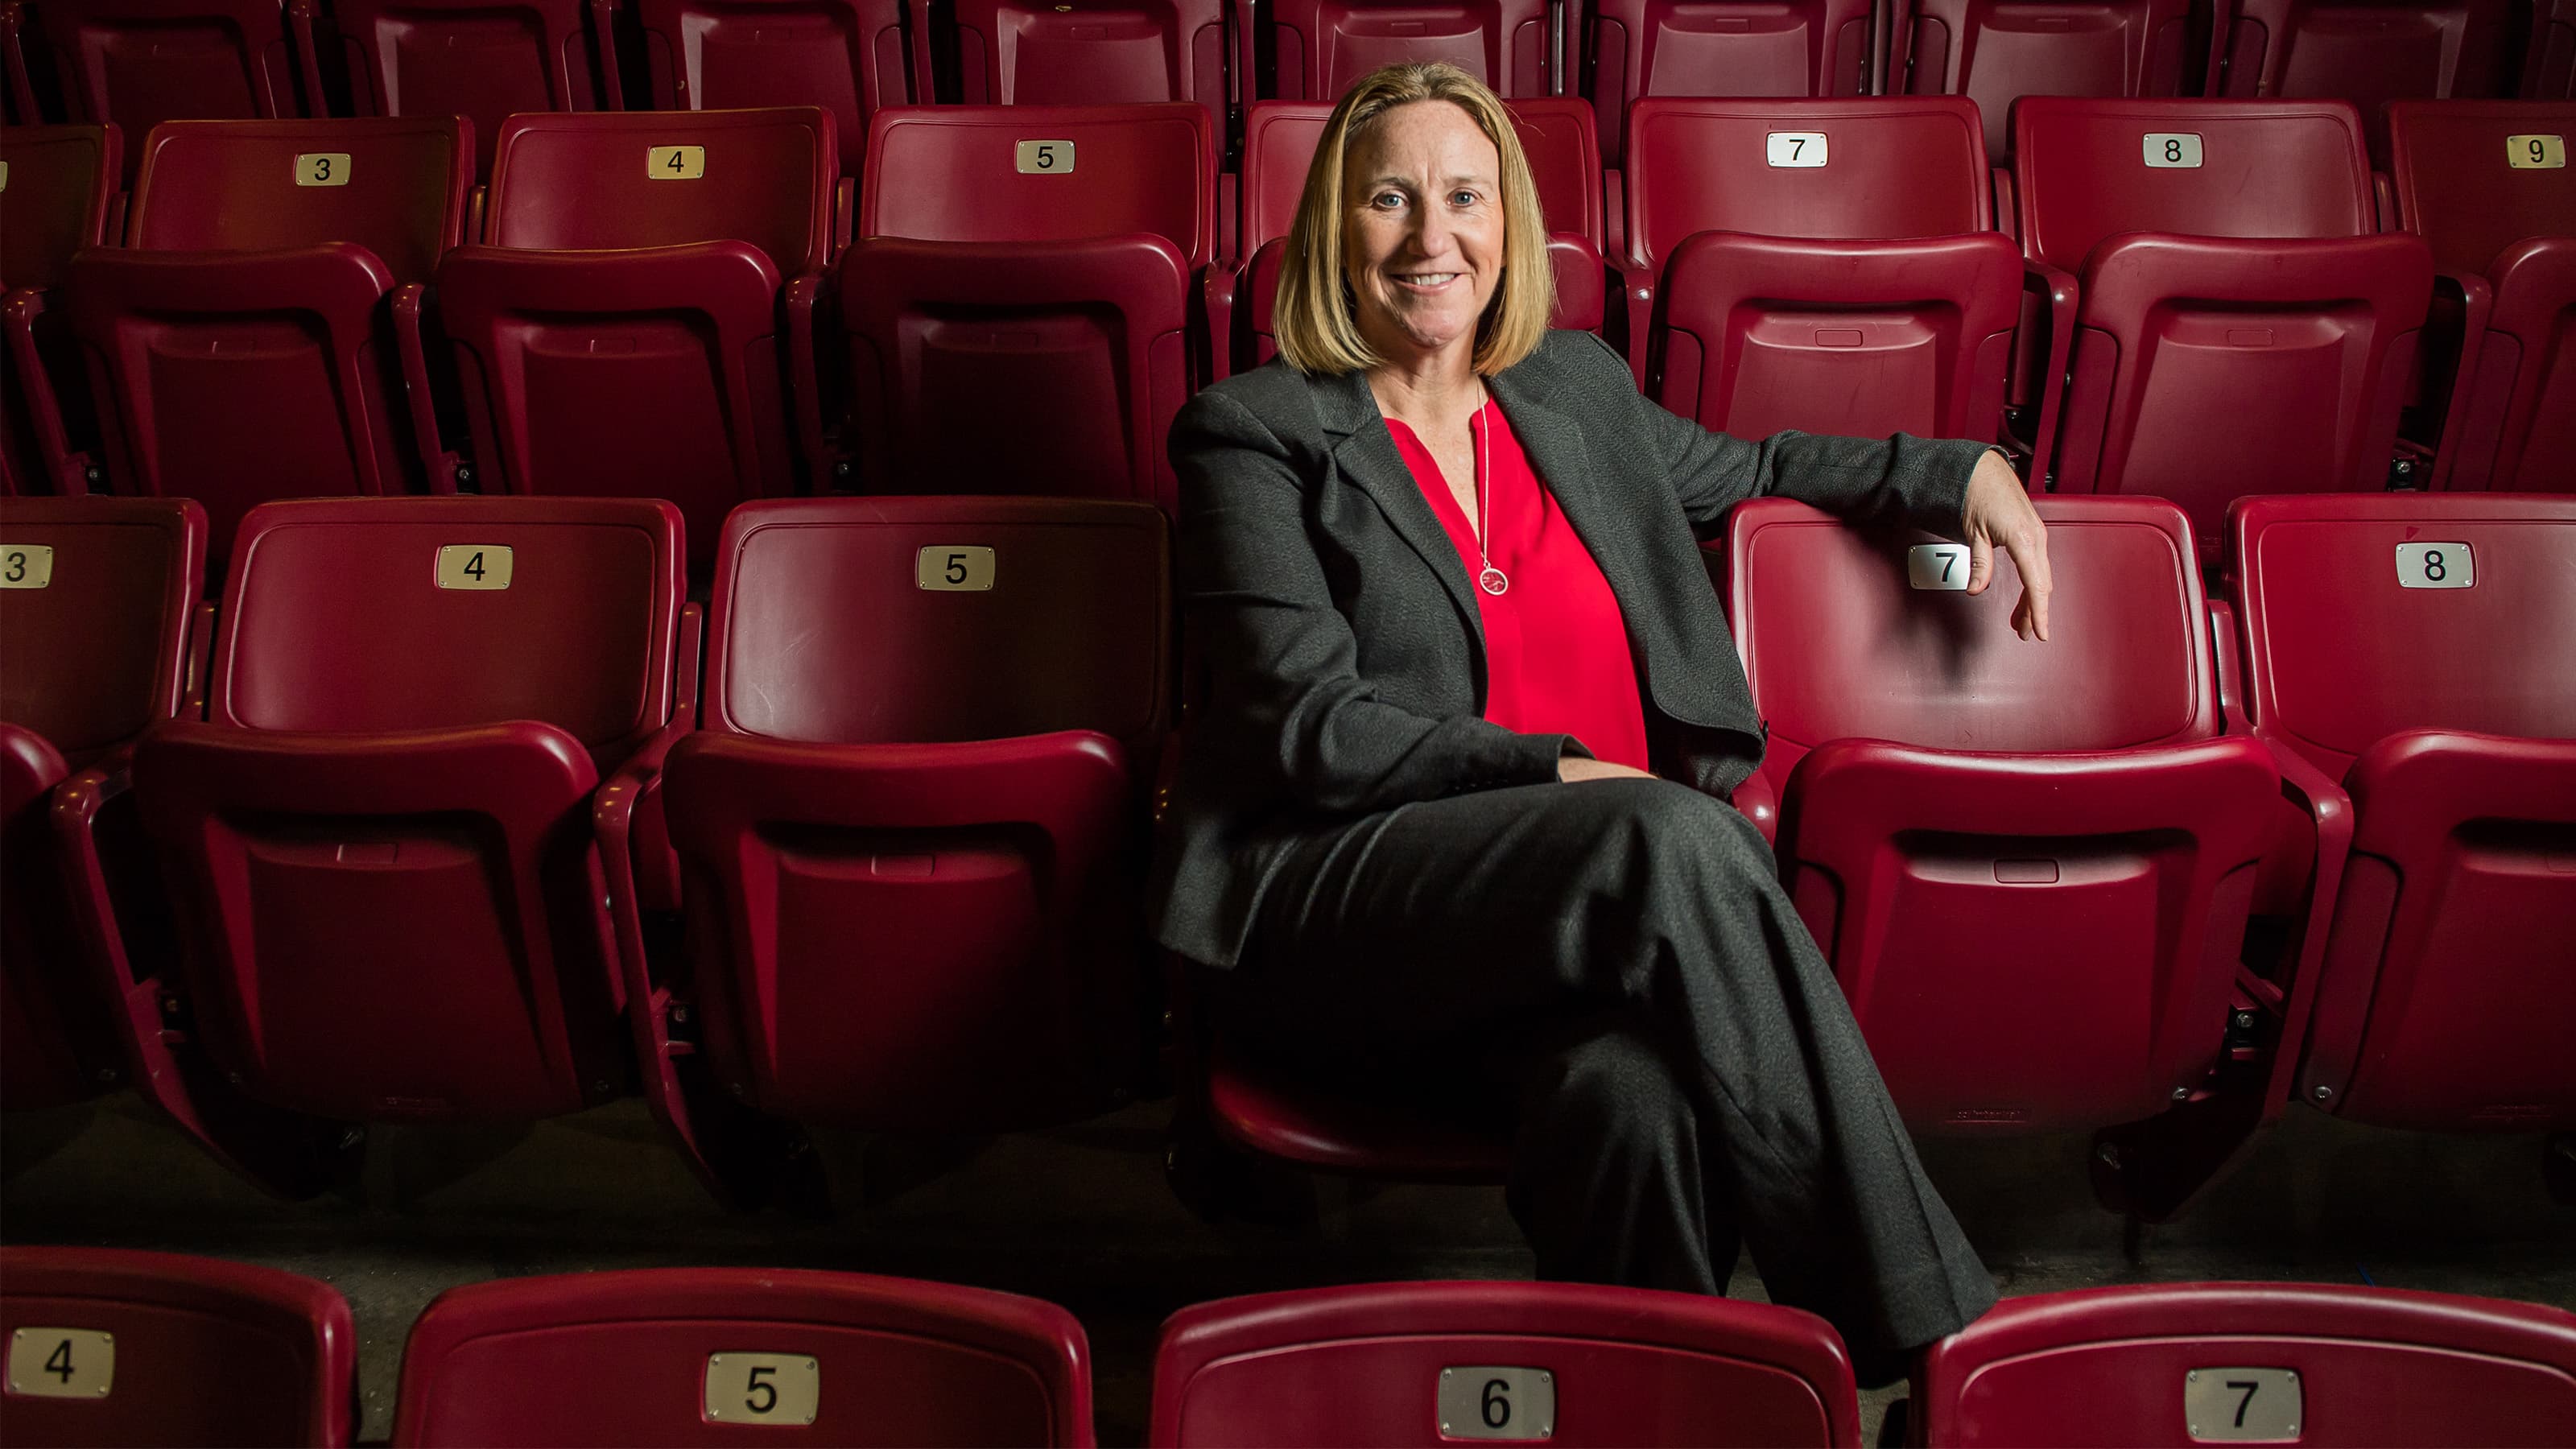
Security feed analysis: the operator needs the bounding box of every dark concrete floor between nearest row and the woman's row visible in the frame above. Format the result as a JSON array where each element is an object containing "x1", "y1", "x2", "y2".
[{"x1": 0, "y1": 1098, "x2": 2576, "y2": 1444}]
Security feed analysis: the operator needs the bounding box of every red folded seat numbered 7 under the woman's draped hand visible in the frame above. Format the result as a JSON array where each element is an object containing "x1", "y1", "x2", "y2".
[{"x1": 1726, "y1": 497, "x2": 2280, "y2": 1206}]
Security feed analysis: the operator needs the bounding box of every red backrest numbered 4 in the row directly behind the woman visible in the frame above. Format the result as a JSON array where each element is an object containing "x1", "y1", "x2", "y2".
[{"x1": 485, "y1": 105, "x2": 840, "y2": 276}]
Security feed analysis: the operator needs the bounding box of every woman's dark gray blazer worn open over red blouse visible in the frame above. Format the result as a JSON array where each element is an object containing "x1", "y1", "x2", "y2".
[{"x1": 1149, "y1": 332, "x2": 1986, "y2": 967}]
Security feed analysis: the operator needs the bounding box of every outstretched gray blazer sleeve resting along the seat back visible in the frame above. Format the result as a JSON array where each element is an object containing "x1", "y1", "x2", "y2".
[{"x1": 1587, "y1": 332, "x2": 1994, "y2": 539}]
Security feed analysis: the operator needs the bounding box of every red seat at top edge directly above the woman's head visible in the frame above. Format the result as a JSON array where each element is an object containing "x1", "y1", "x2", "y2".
[{"x1": 1265, "y1": 0, "x2": 1571, "y2": 101}]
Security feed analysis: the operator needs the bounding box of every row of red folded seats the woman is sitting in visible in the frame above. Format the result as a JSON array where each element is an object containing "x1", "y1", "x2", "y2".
[{"x1": 0, "y1": 495, "x2": 2576, "y2": 1217}]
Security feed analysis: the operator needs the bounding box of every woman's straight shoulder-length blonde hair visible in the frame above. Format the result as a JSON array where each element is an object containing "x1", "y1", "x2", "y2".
[{"x1": 1273, "y1": 62, "x2": 1556, "y2": 377}]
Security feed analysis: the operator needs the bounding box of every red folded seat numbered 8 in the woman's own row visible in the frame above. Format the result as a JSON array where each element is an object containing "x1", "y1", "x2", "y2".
[{"x1": 2228, "y1": 495, "x2": 2576, "y2": 1132}]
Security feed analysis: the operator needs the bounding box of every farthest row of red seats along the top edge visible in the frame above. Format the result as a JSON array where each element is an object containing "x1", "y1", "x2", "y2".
[{"x1": 0, "y1": 0, "x2": 2576, "y2": 180}]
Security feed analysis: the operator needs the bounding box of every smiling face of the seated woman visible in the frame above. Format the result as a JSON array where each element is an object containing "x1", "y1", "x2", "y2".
[{"x1": 1342, "y1": 101, "x2": 1502, "y2": 358}]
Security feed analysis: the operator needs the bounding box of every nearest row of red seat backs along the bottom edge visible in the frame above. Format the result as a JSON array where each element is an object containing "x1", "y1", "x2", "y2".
[{"x1": 0, "y1": 1248, "x2": 2576, "y2": 1449}]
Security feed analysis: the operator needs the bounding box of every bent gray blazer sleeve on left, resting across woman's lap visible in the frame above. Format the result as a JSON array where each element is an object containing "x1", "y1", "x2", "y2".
[{"x1": 1172, "y1": 392, "x2": 1589, "y2": 815}]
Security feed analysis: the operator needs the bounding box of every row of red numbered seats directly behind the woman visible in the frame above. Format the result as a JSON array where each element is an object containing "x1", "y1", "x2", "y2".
[{"x1": 5, "y1": 98, "x2": 2576, "y2": 572}]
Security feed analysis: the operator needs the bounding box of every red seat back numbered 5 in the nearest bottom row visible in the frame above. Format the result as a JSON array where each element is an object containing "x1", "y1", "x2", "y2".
[{"x1": 394, "y1": 1269, "x2": 1092, "y2": 1447}]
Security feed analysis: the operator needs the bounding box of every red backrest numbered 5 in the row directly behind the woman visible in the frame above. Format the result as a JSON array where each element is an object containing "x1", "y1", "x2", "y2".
[{"x1": 858, "y1": 103, "x2": 1216, "y2": 270}]
